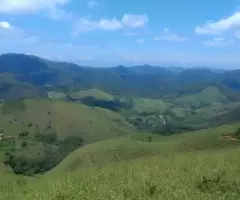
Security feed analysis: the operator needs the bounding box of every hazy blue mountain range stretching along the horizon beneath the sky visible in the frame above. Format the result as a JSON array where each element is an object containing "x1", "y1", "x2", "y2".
[{"x1": 0, "y1": 54, "x2": 240, "y2": 98}]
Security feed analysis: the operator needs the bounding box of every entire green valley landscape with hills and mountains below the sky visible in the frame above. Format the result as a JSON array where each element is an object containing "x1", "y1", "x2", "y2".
[{"x1": 0, "y1": 54, "x2": 240, "y2": 200}]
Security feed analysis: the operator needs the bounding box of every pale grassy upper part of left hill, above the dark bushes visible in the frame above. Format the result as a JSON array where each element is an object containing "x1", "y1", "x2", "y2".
[{"x1": 0, "y1": 100, "x2": 133, "y2": 143}]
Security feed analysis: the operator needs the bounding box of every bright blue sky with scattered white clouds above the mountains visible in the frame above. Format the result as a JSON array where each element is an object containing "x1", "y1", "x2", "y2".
[{"x1": 0, "y1": 0, "x2": 240, "y2": 69}]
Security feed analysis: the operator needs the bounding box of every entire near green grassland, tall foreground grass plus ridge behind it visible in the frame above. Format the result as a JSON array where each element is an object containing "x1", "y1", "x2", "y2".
[{"x1": 0, "y1": 124, "x2": 240, "y2": 200}]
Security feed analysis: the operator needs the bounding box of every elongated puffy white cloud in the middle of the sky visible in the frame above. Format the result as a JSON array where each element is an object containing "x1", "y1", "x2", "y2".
[{"x1": 74, "y1": 14, "x2": 148, "y2": 36}]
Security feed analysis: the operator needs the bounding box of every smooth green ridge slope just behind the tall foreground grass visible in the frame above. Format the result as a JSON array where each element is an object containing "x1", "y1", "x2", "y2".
[{"x1": 50, "y1": 124, "x2": 240, "y2": 173}]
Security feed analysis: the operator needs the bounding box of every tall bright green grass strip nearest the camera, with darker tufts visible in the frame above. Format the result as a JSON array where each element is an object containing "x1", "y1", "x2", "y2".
[{"x1": 0, "y1": 149, "x2": 240, "y2": 200}]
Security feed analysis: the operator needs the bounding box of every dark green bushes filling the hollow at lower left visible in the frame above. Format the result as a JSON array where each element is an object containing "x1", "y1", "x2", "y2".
[{"x1": 4, "y1": 133, "x2": 84, "y2": 175}]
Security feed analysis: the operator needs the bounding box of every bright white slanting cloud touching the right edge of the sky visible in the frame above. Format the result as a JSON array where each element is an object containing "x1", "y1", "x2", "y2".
[{"x1": 195, "y1": 12, "x2": 240, "y2": 35}]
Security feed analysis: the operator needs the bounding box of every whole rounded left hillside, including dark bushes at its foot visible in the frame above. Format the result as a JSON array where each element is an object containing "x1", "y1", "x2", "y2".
[{"x1": 0, "y1": 99, "x2": 134, "y2": 175}]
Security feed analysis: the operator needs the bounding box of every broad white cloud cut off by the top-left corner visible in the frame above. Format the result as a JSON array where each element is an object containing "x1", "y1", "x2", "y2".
[{"x1": 0, "y1": 0, "x2": 69, "y2": 14}]
